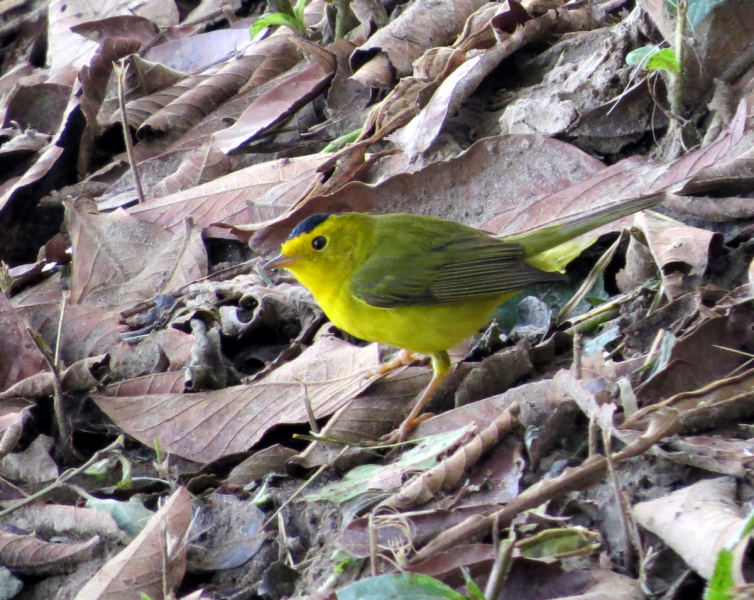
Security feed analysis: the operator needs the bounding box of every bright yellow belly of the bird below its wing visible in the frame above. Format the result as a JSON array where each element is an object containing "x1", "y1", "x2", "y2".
[{"x1": 318, "y1": 292, "x2": 514, "y2": 354}]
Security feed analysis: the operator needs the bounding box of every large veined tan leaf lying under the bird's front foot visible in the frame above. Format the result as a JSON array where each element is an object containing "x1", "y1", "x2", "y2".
[{"x1": 94, "y1": 337, "x2": 379, "y2": 462}]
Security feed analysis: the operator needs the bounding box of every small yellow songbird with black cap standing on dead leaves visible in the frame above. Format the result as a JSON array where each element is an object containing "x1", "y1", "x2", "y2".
[{"x1": 265, "y1": 194, "x2": 663, "y2": 442}]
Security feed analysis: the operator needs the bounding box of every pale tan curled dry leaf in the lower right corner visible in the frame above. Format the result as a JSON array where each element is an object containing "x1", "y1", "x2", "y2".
[{"x1": 633, "y1": 477, "x2": 746, "y2": 585}]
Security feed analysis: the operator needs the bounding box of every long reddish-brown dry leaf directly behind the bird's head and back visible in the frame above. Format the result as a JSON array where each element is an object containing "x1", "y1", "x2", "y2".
[{"x1": 253, "y1": 136, "x2": 605, "y2": 251}]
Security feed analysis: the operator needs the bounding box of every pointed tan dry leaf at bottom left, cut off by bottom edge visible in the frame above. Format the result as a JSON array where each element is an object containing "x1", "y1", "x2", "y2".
[{"x1": 76, "y1": 488, "x2": 191, "y2": 600}]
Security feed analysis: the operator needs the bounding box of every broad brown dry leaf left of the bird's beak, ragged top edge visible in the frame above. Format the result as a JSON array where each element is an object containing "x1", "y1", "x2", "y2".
[{"x1": 66, "y1": 197, "x2": 207, "y2": 311}]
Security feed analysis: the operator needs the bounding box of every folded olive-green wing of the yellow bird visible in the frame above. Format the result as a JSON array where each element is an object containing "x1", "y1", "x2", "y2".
[{"x1": 351, "y1": 230, "x2": 563, "y2": 308}]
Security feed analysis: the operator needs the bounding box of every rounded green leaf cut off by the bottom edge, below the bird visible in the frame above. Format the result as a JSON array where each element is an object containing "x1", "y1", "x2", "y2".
[{"x1": 336, "y1": 573, "x2": 467, "y2": 600}]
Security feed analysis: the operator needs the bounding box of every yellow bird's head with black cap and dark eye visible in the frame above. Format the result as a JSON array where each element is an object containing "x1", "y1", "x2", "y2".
[{"x1": 264, "y1": 213, "x2": 368, "y2": 287}]
